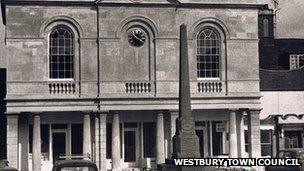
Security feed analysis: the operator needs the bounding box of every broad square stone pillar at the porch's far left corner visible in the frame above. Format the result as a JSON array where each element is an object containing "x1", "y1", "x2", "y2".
[{"x1": 6, "y1": 114, "x2": 19, "y2": 168}]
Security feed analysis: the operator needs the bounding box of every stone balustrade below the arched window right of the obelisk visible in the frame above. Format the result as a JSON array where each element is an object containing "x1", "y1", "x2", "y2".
[{"x1": 197, "y1": 80, "x2": 225, "y2": 93}]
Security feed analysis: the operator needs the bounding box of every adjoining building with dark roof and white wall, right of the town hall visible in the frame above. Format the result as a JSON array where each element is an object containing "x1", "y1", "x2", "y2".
[{"x1": 259, "y1": 7, "x2": 304, "y2": 157}]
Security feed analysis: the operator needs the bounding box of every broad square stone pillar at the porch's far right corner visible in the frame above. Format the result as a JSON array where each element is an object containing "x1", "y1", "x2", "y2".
[{"x1": 248, "y1": 109, "x2": 261, "y2": 158}]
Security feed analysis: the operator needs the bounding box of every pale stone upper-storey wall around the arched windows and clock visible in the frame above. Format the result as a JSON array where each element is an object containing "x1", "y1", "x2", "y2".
[{"x1": 2, "y1": 1, "x2": 260, "y2": 110}]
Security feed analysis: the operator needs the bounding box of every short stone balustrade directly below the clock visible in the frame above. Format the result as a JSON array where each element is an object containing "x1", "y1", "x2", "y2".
[{"x1": 125, "y1": 81, "x2": 153, "y2": 94}]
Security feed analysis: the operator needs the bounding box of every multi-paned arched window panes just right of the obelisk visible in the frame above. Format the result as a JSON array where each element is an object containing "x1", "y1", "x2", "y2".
[{"x1": 197, "y1": 28, "x2": 221, "y2": 78}]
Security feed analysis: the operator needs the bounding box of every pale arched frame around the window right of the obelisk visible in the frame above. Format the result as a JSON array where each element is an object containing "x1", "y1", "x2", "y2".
[{"x1": 194, "y1": 26, "x2": 226, "y2": 81}]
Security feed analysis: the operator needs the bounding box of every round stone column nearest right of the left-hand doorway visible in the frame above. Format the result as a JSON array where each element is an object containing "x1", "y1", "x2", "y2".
[{"x1": 83, "y1": 114, "x2": 92, "y2": 158}]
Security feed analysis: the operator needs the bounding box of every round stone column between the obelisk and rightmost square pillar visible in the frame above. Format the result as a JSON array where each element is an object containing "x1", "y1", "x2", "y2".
[{"x1": 229, "y1": 109, "x2": 238, "y2": 158}]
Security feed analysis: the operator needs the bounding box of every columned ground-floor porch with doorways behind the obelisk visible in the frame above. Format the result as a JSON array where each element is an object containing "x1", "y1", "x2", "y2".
[{"x1": 7, "y1": 109, "x2": 260, "y2": 171}]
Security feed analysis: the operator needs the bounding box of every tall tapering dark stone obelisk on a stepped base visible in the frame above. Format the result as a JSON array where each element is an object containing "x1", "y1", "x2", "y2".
[{"x1": 173, "y1": 24, "x2": 200, "y2": 158}]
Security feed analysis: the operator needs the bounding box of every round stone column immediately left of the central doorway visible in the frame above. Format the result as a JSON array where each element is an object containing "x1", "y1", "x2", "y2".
[{"x1": 112, "y1": 113, "x2": 121, "y2": 171}]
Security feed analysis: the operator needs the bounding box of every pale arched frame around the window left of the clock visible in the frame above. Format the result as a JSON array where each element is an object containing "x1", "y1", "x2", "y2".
[{"x1": 47, "y1": 24, "x2": 77, "y2": 81}]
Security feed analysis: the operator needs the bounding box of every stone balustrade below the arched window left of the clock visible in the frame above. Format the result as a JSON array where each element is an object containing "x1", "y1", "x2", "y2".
[{"x1": 48, "y1": 82, "x2": 76, "y2": 94}]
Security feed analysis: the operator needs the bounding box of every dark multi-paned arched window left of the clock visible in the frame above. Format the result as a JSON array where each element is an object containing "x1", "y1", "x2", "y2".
[{"x1": 49, "y1": 26, "x2": 74, "y2": 79}]
